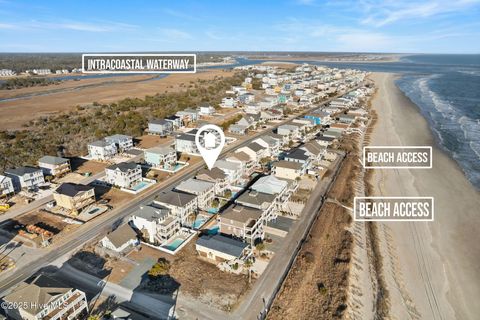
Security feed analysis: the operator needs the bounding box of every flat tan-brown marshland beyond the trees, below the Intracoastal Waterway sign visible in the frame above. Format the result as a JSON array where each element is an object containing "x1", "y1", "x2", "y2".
[{"x1": 0, "y1": 69, "x2": 233, "y2": 130}]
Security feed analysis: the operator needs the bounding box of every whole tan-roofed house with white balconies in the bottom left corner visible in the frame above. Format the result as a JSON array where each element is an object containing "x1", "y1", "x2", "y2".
[{"x1": 3, "y1": 274, "x2": 88, "y2": 320}]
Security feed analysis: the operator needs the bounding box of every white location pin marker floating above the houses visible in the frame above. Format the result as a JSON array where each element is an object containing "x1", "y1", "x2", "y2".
[{"x1": 195, "y1": 124, "x2": 225, "y2": 170}]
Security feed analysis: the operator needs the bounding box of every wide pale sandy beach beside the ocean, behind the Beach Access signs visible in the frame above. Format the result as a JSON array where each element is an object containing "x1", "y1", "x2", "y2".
[{"x1": 370, "y1": 73, "x2": 480, "y2": 320}]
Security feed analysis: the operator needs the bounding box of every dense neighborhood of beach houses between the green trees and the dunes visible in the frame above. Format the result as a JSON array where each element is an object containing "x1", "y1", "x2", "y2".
[{"x1": 0, "y1": 64, "x2": 373, "y2": 319}]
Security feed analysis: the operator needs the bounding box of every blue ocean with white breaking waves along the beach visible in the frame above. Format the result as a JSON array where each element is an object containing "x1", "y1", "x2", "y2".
[{"x1": 238, "y1": 54, "x2": 480, "y2": 189}]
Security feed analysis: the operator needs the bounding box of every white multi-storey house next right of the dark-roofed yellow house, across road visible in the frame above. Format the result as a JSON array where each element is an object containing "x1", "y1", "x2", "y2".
[{"x1": 105, "y1": 162, "x2": 142, "y2": 189}]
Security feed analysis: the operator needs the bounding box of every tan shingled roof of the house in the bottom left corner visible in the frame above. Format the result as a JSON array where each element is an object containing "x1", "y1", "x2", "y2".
[{"x1": 3, "y1": 274, "x2": 72, "y2": 315}]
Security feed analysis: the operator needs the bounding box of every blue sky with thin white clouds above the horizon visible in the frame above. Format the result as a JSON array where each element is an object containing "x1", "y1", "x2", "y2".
[{"x1": 0, "y1": 0, "x2": 480, "y2": 53}]
